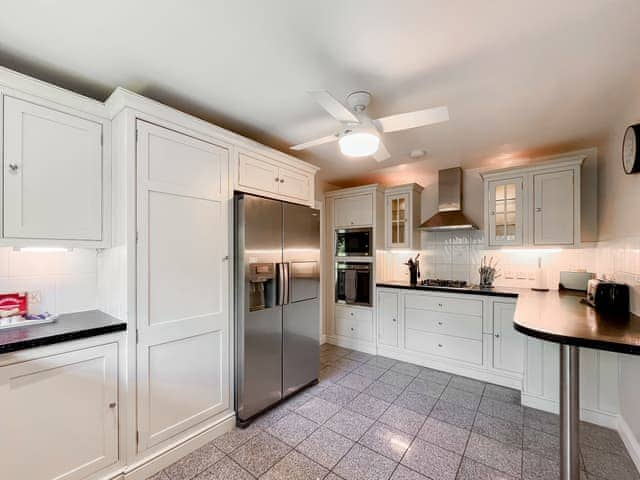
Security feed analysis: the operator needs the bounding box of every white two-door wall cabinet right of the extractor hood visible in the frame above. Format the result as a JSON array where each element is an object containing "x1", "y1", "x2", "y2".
[{"x1": 483, "y1": 157, "x2": 584, "y2": 247}]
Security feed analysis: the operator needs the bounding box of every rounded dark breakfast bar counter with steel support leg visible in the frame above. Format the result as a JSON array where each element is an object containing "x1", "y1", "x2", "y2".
[{"x1": 513, "y1": 289, "x2": 640, "y2": 480}]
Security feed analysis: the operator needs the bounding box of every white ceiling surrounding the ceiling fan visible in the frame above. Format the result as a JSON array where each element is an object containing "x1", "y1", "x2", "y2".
[{"x1": 0, "y1": 0, "x2": 640, "y2": 185}]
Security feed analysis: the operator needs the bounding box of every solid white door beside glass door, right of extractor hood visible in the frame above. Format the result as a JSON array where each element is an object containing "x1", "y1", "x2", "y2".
[{"x1": 533, "y1": 170, "x2": 575, "y2": 245}]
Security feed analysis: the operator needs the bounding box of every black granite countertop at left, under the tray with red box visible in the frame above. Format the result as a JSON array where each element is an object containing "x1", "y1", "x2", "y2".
[{"x1": 0, "y1": 310, "x2": 127, "y2": 354}]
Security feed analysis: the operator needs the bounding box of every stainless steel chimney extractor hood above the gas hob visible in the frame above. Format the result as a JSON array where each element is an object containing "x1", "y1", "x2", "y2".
[{"x1": 418, "y1": 167, "x2": 478, "y2": 232}]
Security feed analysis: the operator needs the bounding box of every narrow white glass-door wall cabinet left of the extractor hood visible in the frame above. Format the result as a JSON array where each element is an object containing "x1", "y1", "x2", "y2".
[{"x1": 385, "y1": 183, "x2": 423, "y2": 249}]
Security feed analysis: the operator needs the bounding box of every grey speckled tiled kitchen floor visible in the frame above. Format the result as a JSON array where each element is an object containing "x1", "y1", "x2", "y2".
[{"x1": 152, "y1": 345, "x2": 640, "y2": 480}]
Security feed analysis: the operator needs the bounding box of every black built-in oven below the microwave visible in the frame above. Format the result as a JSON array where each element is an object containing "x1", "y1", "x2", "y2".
[{"x1": 336, "y1": 262, "x2": 373, "y2": 306}]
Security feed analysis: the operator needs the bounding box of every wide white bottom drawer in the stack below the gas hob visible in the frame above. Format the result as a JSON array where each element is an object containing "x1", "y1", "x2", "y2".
[{"x1": 406, "y1": 328, "x2": 482, "y2": 365}]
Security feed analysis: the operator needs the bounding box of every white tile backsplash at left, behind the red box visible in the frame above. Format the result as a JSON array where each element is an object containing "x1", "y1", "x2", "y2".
[{"x1": 0, "y1": 247, "x2": 97, "y2": 313}]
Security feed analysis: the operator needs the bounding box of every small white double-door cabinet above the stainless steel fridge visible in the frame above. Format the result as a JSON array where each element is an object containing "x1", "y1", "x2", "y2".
[{"x1": 235, "y1": 148, "x2": 317, "y2": 205}]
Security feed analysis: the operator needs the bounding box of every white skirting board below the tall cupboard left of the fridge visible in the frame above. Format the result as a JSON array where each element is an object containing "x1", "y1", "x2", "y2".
[{"x1": 122, "y1": 413, "x2": 236, "y2": 480}]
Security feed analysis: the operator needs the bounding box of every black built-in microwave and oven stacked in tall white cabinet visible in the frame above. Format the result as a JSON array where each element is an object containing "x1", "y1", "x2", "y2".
[{"x1": 335, "y1": 228, "x2": 373, "y2": 306}]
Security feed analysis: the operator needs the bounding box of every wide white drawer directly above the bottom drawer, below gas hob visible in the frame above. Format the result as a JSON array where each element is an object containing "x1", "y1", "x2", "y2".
[{"x1": 405, "y1": 308, "x2": 482, "y2": 340}]
